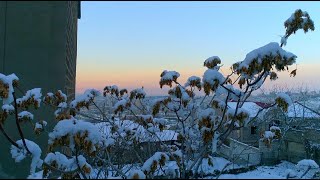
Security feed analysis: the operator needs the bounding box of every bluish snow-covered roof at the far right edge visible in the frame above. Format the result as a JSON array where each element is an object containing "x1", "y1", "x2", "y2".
[{"x1": 287, "y1": 102, "x2": 320, "y2": 118}]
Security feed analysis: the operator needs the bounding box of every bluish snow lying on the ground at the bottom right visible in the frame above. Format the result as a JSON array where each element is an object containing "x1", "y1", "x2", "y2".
[{"x1": 206, "y1": 161, "x2": 319, "y2": 179}]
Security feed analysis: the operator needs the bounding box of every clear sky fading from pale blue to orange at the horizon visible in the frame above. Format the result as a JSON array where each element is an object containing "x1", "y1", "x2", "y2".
[{"x1": 76, "y1": 1, "x2": 320, "y2": 95}]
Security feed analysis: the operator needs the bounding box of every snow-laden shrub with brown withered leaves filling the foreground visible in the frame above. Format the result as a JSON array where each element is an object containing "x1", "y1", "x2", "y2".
[{"x1": 0, "y1": 10, "x2": 314, "y2": 178}]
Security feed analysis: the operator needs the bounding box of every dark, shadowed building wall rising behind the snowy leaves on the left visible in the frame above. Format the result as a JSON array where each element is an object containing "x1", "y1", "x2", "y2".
[{"x1": 0, "y1": 1, "x2": 79, "y2": 178}]
